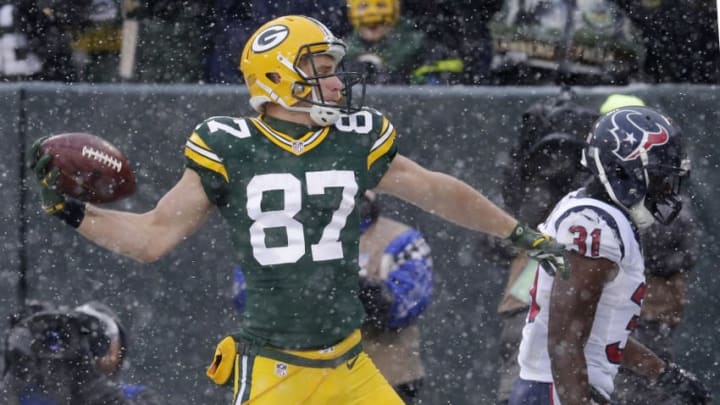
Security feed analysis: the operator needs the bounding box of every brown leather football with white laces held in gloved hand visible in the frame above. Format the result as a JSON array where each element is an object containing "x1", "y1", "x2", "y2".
[{"x1": 40, "y1": 132, "x2": 136, "y2": 204}]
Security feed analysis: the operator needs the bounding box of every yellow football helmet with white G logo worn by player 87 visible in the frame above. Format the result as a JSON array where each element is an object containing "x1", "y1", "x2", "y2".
[{"x1": 240, "y1": 15, "x2": 365, "y2": 126}]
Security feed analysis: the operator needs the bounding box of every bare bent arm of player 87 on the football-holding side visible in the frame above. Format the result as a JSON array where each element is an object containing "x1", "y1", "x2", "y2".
[{"x1": 78, "y1": 169, "x2": 211, "y2": 262}]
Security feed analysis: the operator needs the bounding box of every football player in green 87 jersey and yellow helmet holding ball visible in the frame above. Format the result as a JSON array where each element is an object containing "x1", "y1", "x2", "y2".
[{"x1": 30, "y1": 16, "x2": 565, "y2": 404}]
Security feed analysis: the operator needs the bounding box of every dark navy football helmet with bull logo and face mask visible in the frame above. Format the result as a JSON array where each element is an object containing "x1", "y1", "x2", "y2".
[{"x1": 582, "y1": 107, "x2": 689, "y2": 228}]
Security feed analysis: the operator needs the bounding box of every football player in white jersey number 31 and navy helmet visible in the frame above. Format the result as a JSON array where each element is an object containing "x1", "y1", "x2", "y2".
[{"x1": 509, "y1": 107, "x2": 709, "y2": 405}]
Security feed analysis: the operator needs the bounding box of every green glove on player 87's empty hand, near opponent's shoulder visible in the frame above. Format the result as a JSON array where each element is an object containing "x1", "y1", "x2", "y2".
[{"x1": 508, "y1": 223, "x2": 570, "y2": 280}]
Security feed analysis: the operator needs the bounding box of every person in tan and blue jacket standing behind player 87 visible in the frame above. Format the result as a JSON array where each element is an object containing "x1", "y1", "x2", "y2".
[{"x1": 233, "y1": 191, "x2": 432, "y2": 404}]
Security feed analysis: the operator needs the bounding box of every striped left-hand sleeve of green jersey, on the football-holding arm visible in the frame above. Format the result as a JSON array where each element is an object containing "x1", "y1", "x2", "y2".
[{"x1": 184, "y1": 117, "x2": 237, "y2": 204}]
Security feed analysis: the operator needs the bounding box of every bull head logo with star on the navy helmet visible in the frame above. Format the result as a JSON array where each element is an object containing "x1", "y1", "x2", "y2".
[{"x1": 610, "y1": 110, "x2": 670, "y2": 161}]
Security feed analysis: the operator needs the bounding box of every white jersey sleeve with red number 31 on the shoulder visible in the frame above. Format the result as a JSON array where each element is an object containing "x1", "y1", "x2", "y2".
[{"x1": 556, "y1": 206, "x2": 630, "y2": 263}]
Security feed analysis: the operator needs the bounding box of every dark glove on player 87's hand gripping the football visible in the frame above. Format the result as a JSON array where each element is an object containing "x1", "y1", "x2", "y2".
[{"x1": 27, "y1": 137, "x2": 85, "y2": 228}]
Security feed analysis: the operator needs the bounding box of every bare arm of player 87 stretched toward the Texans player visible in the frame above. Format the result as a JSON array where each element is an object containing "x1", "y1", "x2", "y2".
[{"x1": 377, "y1": 155, "x2": 518, "y2": 238}]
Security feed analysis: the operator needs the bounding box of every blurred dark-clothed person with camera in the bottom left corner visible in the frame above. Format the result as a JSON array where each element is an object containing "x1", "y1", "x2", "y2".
[{"x1": 3, "y1": 301, "x2": 161, "y2": 405}]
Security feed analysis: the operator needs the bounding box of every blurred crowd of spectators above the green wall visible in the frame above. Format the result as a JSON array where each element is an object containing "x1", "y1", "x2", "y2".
[{"x1": 0, "y1": 0, "x2": 720, "y2": 85}]
